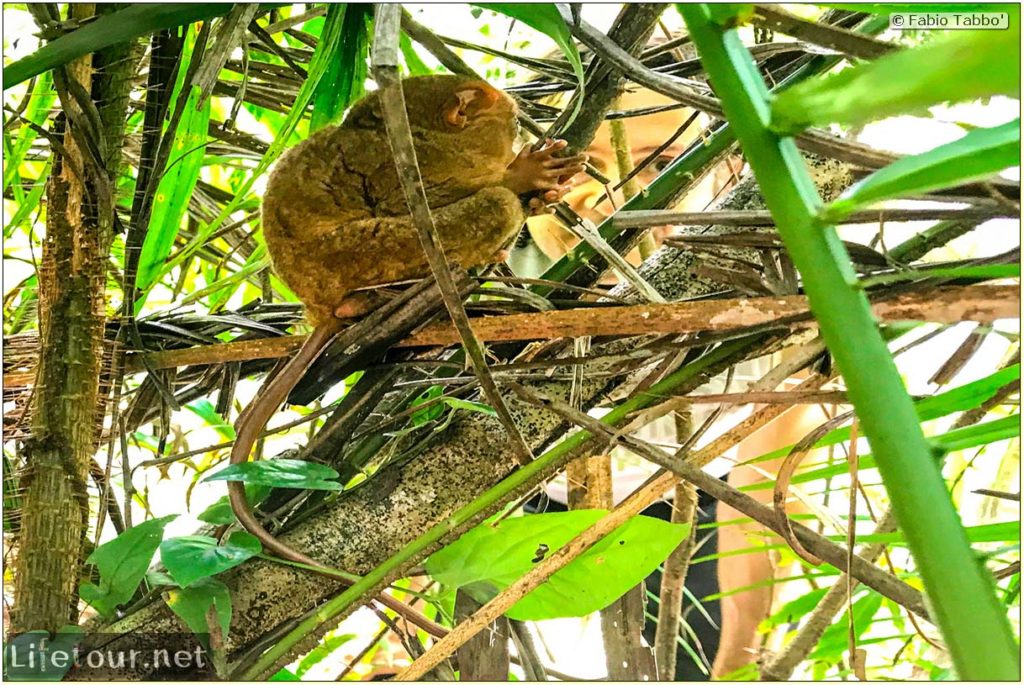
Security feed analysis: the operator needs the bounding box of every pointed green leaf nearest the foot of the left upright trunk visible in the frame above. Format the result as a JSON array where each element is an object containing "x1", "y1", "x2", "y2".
[{"x1": 80, "y1": 514, "x2": 177, "y2": 617}]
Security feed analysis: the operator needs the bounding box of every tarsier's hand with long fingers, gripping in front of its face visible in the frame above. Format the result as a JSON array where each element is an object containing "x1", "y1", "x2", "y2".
[{"x1": 503, "y1": 139, "x2": 588, "y2": 214}]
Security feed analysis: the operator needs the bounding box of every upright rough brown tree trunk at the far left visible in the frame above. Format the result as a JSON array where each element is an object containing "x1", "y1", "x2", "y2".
[{"x1": 11, "y1": 4, "x2": 137, "y2": 633}]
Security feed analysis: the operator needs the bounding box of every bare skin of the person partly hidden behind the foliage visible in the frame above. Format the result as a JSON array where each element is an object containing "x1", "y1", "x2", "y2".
[{"x1": 527, "y1": 90, "x2": 816, "y2": 678}]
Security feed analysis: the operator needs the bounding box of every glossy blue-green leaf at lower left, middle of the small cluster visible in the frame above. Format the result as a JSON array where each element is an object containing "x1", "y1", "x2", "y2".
[{"x1": 160, "y1": 531, "x2": 263, "y2": 588}]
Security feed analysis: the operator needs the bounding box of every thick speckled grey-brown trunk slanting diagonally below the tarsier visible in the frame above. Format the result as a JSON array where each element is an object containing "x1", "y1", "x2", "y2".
[{"x1": 77, "y1": 156, "x2": 850, "y2": 680}]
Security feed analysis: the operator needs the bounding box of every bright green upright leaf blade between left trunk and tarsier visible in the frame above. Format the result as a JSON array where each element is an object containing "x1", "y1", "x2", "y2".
[{"x1": 135, "y1": 86, "x2": 212, "y2": 301}]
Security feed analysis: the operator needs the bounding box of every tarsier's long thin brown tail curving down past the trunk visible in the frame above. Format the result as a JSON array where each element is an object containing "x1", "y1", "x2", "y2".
[{"x1": 227, "y1": 319, "x2": 447, "y2": 637}]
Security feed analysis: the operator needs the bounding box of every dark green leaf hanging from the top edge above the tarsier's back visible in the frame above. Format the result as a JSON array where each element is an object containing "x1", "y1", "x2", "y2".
[{"x1": 309, "y1": 3, "x2": 373, "y2": 132}]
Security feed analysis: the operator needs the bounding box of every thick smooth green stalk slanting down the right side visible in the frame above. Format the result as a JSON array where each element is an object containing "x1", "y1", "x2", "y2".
[{"x1": 680, "y1": 4, "x2": 1020, "y2": 680}]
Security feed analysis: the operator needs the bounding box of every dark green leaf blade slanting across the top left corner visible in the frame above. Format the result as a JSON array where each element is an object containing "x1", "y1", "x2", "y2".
[{"x1": 3, "y1": 2, "x2": 234, "y2": 90}]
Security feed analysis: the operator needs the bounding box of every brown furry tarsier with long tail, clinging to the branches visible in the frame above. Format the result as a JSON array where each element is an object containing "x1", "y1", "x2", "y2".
[{"x1": 228, "y1": 75, "x2": 586, "y2": 626}]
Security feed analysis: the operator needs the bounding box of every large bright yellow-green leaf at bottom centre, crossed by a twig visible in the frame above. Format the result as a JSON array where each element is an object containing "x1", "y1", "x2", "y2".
[{"x1": 425, "y1": 509, "x2": 689, "y2": 620}]
